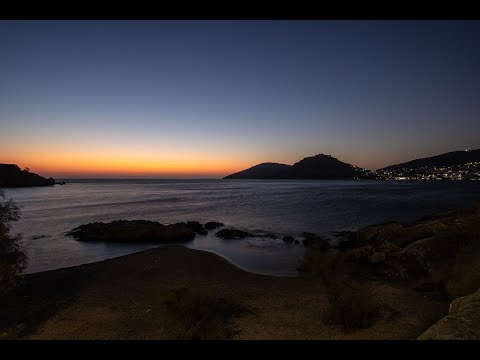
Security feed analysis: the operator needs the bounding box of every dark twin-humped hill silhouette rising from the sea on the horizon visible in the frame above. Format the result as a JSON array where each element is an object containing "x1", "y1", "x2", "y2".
[{"x1": 225, "y1": 154, "x2": 374, "y2": 180}]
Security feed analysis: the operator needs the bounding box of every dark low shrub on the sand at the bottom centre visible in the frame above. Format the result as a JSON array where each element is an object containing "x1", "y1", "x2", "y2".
[{"x1": 163, "y1": 287, "x2": 245, "y2": 340}]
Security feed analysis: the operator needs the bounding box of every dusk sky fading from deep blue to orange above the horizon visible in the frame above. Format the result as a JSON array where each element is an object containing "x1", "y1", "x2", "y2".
[{"x1": 0, "y1": 21, "x2": 480, "y2": 178}]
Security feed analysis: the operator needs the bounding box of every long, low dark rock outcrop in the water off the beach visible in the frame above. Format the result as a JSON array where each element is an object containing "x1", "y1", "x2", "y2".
[{"x1": 67, "y1": 220, "x2": 195, "y2": 242}]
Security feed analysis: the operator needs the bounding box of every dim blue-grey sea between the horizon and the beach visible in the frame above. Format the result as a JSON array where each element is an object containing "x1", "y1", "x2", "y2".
[{"x1": 6, "y1": 180, "x2": 480, "y2": 275}]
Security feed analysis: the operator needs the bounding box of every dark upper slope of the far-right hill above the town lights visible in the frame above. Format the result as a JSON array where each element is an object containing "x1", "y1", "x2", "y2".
[{"x1": 377, "y1": 149, "x2": 480, "y2": 171}]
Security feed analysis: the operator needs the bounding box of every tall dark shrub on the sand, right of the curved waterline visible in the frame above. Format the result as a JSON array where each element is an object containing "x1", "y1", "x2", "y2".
[{"x1": 300, "y1": 243, "x2": 375, "y2": 332}]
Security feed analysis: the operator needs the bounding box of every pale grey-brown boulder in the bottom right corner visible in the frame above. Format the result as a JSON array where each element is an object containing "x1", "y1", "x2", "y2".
[{"x1": 418, "y1": 290, "x2": 480, "y2": 340}]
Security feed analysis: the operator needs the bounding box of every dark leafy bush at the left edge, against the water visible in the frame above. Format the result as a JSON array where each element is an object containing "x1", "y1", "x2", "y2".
[{"x1": 0, "y1": 190, "x2": 27, "y2": 295}]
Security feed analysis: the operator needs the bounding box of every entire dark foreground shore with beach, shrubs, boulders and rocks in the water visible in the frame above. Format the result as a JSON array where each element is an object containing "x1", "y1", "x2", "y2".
[{"x1": 0, "y1": 207, "x2": 480, "y2": 339}]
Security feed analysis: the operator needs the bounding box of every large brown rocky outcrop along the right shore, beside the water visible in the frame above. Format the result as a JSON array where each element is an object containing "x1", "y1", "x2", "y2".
[{"x1": 339, "y1": 207, "x2": 480, "y2": 284}]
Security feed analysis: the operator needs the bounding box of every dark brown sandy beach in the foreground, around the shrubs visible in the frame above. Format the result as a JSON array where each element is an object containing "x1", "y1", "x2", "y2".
[{"x1": 0, "y1": 246, "x2": 448, "y2": 339}]
